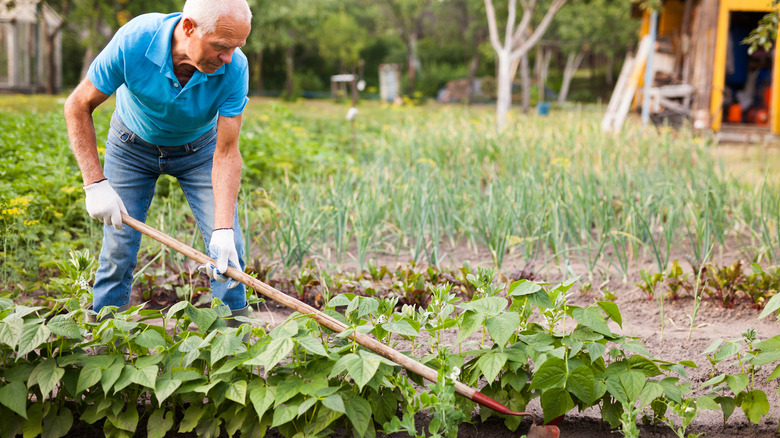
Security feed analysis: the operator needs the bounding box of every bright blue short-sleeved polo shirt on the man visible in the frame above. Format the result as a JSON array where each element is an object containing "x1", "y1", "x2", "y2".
[{"x1": 87, "y1": 13, "x2": 249, "y2": 146}]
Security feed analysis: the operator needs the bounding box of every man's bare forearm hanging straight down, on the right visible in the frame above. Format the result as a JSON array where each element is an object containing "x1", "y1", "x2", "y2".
[{"x1": 211, "y1": 114, "x2": 242, "y2": 230}]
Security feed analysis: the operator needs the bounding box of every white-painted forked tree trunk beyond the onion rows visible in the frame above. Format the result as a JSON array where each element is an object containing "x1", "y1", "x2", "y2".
[{"x1": 485, "y1": 0, "x2": 566, "y2": 131}]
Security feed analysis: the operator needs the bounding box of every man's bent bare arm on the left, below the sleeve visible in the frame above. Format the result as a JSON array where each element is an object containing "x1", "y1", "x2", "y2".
[{"x1": 65, "y1": 79, "x2": 109, "y2": 187}]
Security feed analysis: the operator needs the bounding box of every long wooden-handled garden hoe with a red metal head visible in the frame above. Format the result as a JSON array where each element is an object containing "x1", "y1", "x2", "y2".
[{"x1": 122, "y1": 213, "x2": 560, "y2": 438}]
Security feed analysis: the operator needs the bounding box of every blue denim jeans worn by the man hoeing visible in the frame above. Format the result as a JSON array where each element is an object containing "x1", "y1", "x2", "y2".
[{"x1": 92, "y1": 113, "x2": 247, "y2": 312}]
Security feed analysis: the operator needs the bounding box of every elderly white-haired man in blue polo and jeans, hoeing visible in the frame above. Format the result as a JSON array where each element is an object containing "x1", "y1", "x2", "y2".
[{"x1": 65, "y1": 0, "x2": 252, "y2": 325}]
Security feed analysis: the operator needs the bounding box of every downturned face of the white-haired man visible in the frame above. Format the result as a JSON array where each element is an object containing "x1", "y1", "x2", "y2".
[{"x1": 188, "y1": 18, "x2": 250, "y2": 73}]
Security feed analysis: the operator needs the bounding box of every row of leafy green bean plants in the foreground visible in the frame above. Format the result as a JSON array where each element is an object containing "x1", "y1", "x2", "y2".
[{"x1": 0, "y1": 253, "x2": 780, "y2": 437}]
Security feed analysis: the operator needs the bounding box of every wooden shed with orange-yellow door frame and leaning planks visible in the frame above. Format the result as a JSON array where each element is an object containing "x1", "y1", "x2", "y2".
[{"x1": 602, "y1": 0, "x2": 780, "y2": 140}]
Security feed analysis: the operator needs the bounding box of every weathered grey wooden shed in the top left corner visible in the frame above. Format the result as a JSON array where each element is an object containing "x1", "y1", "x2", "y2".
[{"x1": 0, "y1": 0, "x2": 63, "y2": 93}]
